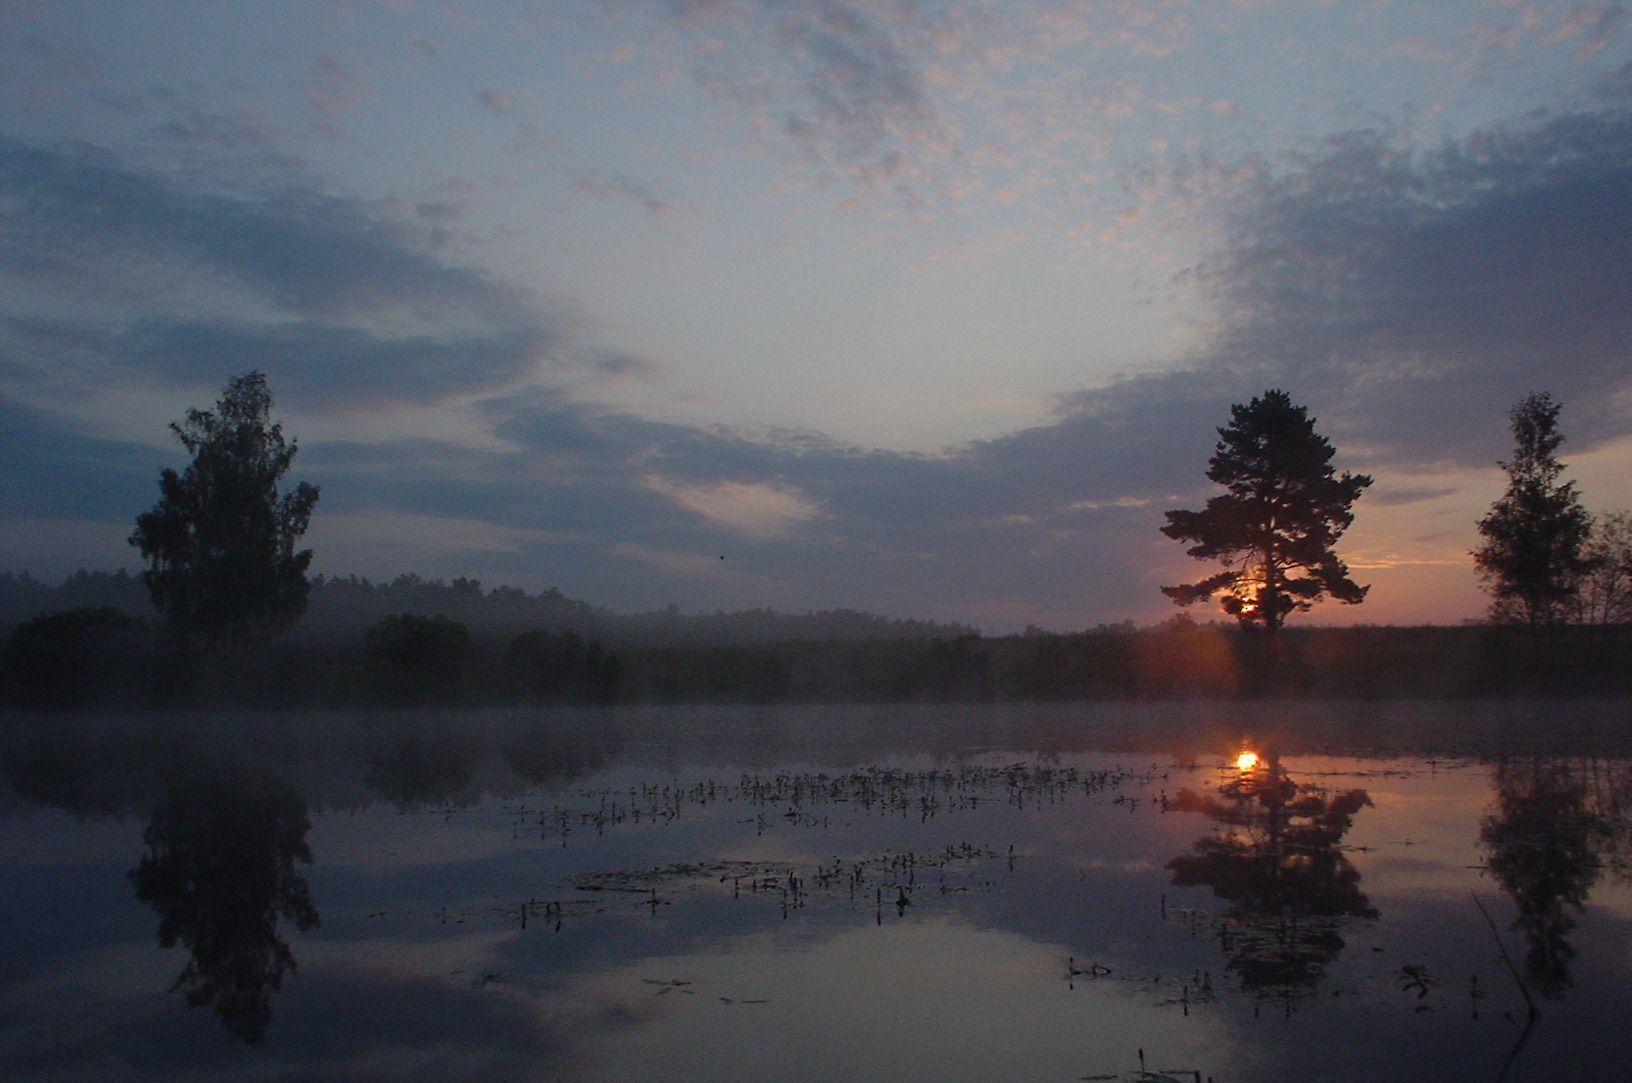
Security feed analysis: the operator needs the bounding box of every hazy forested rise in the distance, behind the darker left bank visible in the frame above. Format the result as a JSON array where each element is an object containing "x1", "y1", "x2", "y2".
[{"x1": 0, "y1": 571, "x2": 976, "y2": 648}]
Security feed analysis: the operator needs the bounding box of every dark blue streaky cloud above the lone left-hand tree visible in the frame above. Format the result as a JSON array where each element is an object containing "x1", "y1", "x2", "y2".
[{"x1": 0, "y1": 139, "x2": 574, "y2": 411}]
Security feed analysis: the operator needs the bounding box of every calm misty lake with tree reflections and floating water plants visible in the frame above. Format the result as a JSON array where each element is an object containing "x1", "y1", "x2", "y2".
[{"x1": 0, "y1": 703, "x2": 1632, "y2": 1083}]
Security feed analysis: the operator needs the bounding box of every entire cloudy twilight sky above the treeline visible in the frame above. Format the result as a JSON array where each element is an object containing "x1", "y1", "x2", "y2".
[{"x1": 0, "y1": 0, "x2": 1632, "y2": 633}]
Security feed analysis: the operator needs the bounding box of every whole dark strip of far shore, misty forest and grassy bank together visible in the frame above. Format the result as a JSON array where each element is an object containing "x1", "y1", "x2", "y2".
[{"x1": 0, "y1": 571, "x2": 1632, "y2": 708}]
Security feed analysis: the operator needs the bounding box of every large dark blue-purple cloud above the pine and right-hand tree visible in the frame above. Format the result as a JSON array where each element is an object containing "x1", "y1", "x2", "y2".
[{"x1": 1196, "y1": 106, "x2": 1632, "y2": 463}]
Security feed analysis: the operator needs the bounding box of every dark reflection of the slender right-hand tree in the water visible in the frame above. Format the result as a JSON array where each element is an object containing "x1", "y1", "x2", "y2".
[{"x1": 1479, "y1": 760, "x2": 1612, "y2": 998}]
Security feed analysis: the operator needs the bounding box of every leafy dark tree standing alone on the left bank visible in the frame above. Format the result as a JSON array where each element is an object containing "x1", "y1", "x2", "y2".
[{"x1": 131, "y1": 372, "x2": 318, "y2": 648}]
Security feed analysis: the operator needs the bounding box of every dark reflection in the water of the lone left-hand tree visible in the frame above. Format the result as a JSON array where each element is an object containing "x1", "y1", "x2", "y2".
[{"x1": 131, "y1": 768, "x2": 318, "y2": 1044}]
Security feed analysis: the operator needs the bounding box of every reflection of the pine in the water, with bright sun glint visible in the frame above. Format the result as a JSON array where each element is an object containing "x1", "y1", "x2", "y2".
[{"x1": 1167, "y1": 757, "x2": 1377, "y2": 1010}]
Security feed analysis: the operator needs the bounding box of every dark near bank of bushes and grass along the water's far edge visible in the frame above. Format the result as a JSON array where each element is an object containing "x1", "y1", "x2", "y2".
[{"x1": 12, "y1": 610, "x2": 1632, "y2": 708}]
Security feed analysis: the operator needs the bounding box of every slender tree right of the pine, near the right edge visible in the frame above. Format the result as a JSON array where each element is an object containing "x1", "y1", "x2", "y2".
[{"x1": 1474, "y1": 393, "x2": 1591, "y2": 628}]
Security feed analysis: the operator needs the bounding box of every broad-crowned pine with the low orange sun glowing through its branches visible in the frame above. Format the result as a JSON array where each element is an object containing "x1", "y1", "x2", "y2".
[{"x1": 1162, "y1": 390, "x2": 1371, "y2": 633}]
